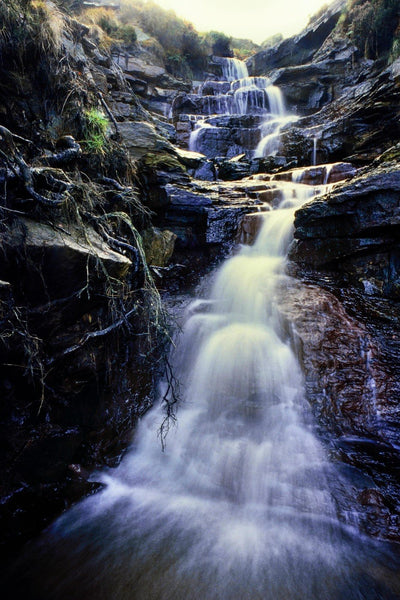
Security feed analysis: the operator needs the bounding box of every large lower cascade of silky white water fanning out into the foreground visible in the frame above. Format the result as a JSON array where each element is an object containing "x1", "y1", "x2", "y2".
[{"x1": 5, "y1": 184, "x2": 400, "y2": 600}]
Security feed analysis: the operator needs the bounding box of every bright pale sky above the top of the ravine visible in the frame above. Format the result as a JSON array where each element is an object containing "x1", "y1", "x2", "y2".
[{"x1": 155, "y1": 0, "x2": 333, "y2": 43}]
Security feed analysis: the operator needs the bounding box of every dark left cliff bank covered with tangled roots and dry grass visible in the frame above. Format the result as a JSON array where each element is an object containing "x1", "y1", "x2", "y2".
[{"x1": 0, "y1": 0, "x2": 180, "y2": 552}]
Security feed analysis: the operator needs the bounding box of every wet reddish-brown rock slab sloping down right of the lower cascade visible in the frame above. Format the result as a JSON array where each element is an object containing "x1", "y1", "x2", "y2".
[{"x1": 278, "y1": 280, "x2": 400, "y2": 541}]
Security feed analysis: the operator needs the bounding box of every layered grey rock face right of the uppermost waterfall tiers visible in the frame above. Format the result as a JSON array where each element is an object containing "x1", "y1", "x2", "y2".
[{"x1": 282, "y1": 61, "x2": 400, "y2": 165}]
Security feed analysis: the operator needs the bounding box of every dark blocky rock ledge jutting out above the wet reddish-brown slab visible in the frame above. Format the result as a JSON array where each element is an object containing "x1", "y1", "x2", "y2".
[{"x1": 290, "y1": 167, "x2": 400, "y2": 298}]
